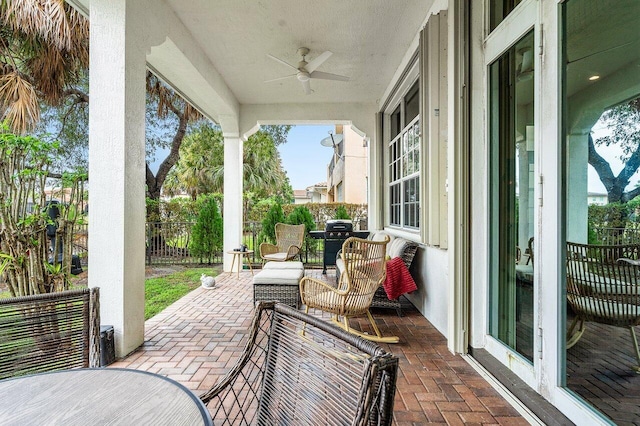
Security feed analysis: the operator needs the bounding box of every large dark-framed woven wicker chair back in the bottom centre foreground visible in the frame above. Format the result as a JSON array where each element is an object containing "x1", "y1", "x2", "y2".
[{"x1": 200, "y1": 302, "x2": 398, "y2": 426}]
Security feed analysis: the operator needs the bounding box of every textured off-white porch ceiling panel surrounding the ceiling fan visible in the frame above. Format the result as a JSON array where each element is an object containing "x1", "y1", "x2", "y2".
[{"x1": 166, "y1": 0, "x2": 434, "y2": 105}]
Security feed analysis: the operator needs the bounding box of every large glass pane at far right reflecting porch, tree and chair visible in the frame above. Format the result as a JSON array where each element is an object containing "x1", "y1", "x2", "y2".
[{"x1": 558, "y1": 0, "x2": 640, "y2": 424}]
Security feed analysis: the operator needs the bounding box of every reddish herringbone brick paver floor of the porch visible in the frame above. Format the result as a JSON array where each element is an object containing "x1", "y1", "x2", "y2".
[{"x1": 111, "y1": 270, "x2": 529, "y2": 426}]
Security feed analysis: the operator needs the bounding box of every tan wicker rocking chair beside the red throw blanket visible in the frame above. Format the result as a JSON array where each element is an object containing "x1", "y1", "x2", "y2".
[{"x1": 300, "y1": 237, "x2": 399, "y2": 343}]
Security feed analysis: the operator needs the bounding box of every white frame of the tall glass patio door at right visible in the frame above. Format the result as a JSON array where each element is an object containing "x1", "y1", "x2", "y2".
[{"x1": 470, "y1": 0, "x2": 624, "y2": 425}]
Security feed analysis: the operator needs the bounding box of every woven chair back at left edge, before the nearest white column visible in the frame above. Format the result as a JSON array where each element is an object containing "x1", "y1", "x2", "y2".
[{"x1": 0, "y1": 288, "x2": 100, "y2": 379}]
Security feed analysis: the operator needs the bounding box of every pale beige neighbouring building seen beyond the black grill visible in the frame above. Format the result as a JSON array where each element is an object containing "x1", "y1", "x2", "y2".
[{"x1": 327, "y1": 126, "x2": 369, "y2": 204}]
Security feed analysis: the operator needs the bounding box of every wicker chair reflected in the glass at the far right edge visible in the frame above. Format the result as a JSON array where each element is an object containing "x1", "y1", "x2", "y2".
[{"x1": 567, "y1": 242, "x2": 640, "y2": 372}]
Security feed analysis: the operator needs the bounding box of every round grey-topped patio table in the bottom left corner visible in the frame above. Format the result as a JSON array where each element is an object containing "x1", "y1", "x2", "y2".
[{"x1": 0, "y1": 368, "x2": 213, "y2": 426}]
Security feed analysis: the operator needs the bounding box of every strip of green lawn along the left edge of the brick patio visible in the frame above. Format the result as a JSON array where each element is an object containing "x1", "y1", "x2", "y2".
[{"x1": 144, "y1": 266, "x2": 221, "y2": 320}]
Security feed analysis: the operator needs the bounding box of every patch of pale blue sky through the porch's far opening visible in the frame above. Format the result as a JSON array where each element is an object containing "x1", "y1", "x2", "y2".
[{"x1": 278, "y1": 126, "x2": 335, "y2": 189}]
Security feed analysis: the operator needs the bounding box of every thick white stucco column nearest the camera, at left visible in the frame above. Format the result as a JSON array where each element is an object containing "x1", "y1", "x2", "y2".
[{"x1": 89, "y1": 0, "x2": 146, "y2": 357}]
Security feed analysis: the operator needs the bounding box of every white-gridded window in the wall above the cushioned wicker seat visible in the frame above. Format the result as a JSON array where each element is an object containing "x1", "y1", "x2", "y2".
[{"x1": 389, "y1": 83, "x2": 420, "y2": 229}]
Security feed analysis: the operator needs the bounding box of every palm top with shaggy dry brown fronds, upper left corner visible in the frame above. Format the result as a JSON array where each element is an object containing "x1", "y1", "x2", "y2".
[{"x1": 0, "y1": 0, "x2": 89, "y2": 134}]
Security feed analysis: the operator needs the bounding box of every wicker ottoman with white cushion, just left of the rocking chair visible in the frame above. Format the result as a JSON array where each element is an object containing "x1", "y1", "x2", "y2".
[{"x1": 253, "y1": 262, "x2": 304, "y2": 309}]
